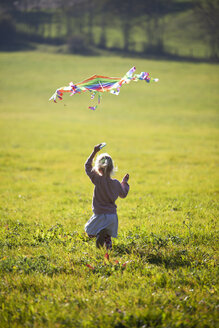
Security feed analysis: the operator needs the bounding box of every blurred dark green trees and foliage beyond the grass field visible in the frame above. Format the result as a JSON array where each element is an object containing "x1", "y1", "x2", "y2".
[{"x1": 0, "y1": 0, "x2": 218, "y2": 60}]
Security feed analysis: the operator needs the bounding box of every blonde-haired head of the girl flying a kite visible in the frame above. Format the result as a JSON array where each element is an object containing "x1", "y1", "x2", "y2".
[{"x1": 93, "y1": 153, "x2": 115, "y2": 177}]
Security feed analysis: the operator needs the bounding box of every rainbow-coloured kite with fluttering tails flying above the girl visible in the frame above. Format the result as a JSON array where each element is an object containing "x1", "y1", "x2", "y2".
[{"x1": 49, "y1": 67, "x2": 158, "y2": 110}]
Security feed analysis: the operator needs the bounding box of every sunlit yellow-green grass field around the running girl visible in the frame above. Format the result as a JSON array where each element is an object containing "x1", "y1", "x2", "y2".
[{"x1": 0, "y1": 52, "x2": 219, "y2": 328}]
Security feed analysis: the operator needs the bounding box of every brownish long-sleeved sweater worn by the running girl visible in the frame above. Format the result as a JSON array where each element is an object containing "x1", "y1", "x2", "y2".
[{"x1": 85, "y1": 154, "x2": 129, "y2": 214}]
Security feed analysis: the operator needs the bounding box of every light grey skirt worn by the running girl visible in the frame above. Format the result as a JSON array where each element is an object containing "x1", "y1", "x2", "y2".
[{"x1": 84, "y1": 214, "x2": 118, "y2": 237}]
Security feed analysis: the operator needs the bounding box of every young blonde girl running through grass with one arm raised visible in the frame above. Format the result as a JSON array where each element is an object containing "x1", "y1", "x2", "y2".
[{"x1": 85, "y1": 144, "x2": 129, "y2": 249}]
